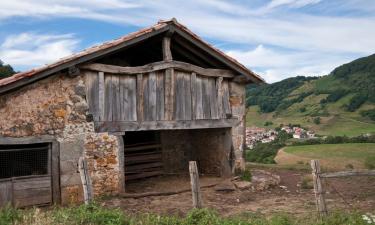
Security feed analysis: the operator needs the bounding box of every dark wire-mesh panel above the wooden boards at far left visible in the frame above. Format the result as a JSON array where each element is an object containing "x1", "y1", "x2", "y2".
[{"x1": 0, "y1": 144, "x2": 49, "y2": 179}]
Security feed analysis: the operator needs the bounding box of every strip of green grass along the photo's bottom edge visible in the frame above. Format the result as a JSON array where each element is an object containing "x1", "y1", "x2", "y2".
[{"x1": 0, "y1": 204, "x2": 374, "y2": 225}]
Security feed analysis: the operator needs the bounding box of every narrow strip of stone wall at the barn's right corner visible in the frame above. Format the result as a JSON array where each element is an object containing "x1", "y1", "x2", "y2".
[{"x1": 229, "y1": 82, "x2": 246, "y2": 172}]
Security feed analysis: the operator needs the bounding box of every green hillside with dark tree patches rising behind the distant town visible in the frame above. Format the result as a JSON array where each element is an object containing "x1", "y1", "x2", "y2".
[{"x1": 247, "y1": 54, "x2": 375, "y2": 136}]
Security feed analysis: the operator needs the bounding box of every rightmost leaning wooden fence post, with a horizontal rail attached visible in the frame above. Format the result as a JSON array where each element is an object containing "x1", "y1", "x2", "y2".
[{"x1": 311, "y1": 160, "x2": 327, "y2": 217}]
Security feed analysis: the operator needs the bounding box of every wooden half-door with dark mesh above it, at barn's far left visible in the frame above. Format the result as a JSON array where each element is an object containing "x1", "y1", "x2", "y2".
[{"x1": 0, "y1": 143, "x2": 53, "y2": 207}]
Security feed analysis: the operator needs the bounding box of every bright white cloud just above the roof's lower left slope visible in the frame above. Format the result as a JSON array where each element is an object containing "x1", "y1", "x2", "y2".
[{"x1": 0, "y1": 33, "x2": 79, "y2": 67}]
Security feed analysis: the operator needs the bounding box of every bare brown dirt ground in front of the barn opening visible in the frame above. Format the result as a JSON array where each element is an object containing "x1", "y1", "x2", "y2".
[{"x1": 103, "y1": 169, "x2": 375, "y2": 216}]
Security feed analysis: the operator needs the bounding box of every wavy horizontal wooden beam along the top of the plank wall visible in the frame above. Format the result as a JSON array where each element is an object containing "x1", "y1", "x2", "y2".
[{"x1": 81, "y1": 61, "x2": 235, "y2": 78}]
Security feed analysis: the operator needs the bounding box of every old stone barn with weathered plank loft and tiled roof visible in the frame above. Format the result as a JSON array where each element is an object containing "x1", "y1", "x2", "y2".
[{"x1": 0, "y1": 19, "x2": 263, "y2": 207}]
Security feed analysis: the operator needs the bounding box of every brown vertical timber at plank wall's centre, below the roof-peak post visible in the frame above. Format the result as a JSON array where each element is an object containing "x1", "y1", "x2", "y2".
[{"x1": 164, "y1": 69, "x2": 175, "y2": 120}]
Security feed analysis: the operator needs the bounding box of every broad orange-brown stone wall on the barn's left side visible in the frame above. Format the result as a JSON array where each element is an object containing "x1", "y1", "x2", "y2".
[{"x1": 0, "y1": 75, "x2": 119, "y2": 204}]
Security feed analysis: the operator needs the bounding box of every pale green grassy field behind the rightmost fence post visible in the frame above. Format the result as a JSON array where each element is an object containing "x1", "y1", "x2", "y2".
[{"x1": 275, "y1": 143, "x2": 375, "y2": 170}]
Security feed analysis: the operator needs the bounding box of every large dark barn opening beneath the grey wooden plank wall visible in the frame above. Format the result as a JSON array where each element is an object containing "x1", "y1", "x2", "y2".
[{"x1": 124, "y1": 128, "x2": 231, "y2": 188}]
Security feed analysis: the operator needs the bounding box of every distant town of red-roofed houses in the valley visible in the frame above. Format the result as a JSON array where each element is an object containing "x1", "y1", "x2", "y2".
[{"x1": 246, "y1": 126, "x2": 315, "y2": 149}]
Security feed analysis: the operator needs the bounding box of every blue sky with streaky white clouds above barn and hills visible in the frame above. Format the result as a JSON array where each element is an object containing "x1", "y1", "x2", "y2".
[{"x1": 0, "y1": 0, "x2": 375, "y2": 82}]
